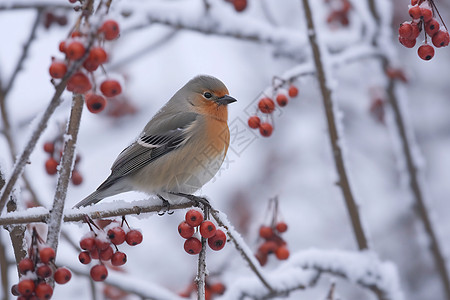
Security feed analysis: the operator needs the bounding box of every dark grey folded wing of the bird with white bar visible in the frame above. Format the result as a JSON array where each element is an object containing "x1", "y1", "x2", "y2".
[{"x1": 97, "y1": 113, "x2": 198, "y2": 190}]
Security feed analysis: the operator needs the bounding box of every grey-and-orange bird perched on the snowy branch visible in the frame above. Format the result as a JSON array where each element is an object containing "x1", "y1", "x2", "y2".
[{"x1": 74, "y1": 75, "x2": 237, "y2": 208}]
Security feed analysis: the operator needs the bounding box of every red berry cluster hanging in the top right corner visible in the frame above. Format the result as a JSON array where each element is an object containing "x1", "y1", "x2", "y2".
[{"x1": 398, "y1": 0, "x2": 450, "y2": 60}]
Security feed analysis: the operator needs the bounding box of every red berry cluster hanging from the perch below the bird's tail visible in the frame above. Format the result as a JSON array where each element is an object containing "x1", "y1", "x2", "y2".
[{"x1": 78, "y1": 219, "x2": 143, "y2": 281}]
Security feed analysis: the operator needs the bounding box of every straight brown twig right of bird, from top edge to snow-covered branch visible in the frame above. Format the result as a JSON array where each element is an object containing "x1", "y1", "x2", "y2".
[{"x1": 302, "y1": 0, "x2": 369, "y2": 250}]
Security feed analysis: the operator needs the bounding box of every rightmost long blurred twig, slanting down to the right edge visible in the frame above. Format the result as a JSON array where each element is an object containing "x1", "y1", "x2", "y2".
[{"x1": 368, "y1": 0, "x2": 450, "y2": 300}]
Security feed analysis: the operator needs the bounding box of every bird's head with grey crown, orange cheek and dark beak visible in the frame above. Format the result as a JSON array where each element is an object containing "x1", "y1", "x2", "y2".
[{"x1": 182, "y1": 75, "x2": 236, "y2": 121}]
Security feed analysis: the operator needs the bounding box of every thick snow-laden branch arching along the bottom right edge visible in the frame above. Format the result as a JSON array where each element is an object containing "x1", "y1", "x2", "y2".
[{"x1": 219, "y1": 249, "x2": 403, "y2": 300}]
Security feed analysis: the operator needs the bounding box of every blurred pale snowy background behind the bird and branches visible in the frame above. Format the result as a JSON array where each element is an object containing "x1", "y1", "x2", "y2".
[{"x1": 0, "y1": 0, "x2": 450, "y2": 300}]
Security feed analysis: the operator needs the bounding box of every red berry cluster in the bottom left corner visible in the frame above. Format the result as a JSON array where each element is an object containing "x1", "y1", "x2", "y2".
[{"x1": 11, "y1": 228, "x2": 72, "y2": 300}]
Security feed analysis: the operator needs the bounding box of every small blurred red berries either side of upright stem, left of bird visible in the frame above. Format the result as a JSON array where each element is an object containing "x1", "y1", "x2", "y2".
[{"x1": 44, "y1": 134, "x2": 83, "y2": 185}]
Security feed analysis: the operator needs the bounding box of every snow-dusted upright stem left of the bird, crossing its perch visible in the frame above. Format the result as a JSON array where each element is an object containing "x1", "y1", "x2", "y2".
[{"x1": 47, "y1": 94, "x2": 84, "y2": 251}]
